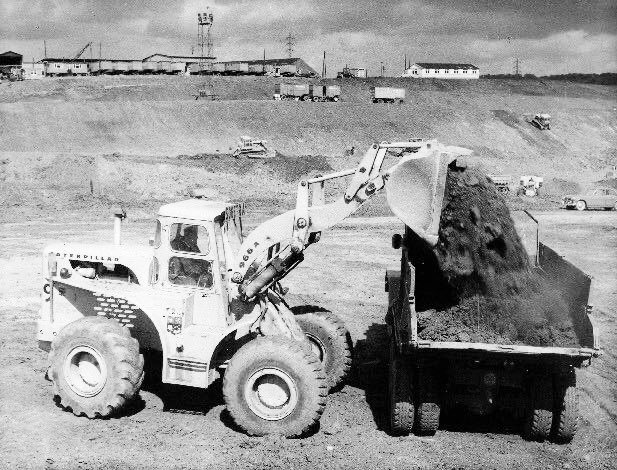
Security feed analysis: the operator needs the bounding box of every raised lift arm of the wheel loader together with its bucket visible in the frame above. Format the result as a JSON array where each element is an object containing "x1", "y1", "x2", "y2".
[{"x1": 231, "y1": 140, "x2": 470, "y2": 299}]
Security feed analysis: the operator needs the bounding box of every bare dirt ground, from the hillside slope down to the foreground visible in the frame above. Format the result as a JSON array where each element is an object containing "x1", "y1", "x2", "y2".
[{"x1": 0, "y1": 77, "x2": 617, "y2": 470}]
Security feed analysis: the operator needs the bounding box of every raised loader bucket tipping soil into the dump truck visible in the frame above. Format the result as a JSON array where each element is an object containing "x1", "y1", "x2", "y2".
[{"x1": 386, "y1": 141, "x2": 471, "y2": 246}]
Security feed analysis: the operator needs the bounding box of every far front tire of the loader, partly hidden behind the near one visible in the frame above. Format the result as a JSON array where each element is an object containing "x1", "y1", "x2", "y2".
[{"x1": 295, "y1": 312, "x2": 353, "y2": 389}]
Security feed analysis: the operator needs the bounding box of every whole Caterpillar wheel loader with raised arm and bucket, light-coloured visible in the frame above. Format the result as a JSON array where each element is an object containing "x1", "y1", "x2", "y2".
[{"x1": 38, "y1": 141, "x2": 468, "y2": 436}]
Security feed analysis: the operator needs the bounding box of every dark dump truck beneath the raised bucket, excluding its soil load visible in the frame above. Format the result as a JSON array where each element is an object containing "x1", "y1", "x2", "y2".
[{"x1": 386, "y1": 218, "x2": 600, "y2": 443}]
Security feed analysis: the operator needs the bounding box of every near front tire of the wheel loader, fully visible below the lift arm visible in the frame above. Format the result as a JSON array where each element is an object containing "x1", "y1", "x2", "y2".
[{"x1": 223, "y1": 336, "x2": 328, "y2": 437}]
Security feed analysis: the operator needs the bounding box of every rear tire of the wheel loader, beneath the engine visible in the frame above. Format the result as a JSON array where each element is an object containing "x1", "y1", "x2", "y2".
[{"x1": 49, "y1": 317, "x2": 144, "y2": 418}]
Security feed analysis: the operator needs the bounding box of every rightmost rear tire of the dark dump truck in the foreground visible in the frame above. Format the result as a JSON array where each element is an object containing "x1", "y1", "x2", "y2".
[{"x1": 552, "y1": 370, "x2": 578, "y2": 444}]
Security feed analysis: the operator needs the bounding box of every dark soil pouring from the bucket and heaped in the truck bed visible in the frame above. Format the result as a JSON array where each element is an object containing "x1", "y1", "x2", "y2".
[{"x1": 416, "y1": 168, "x2": 578, "y2": 347}]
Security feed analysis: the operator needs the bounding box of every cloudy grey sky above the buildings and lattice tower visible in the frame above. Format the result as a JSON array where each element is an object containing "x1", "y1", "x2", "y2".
[{"x1": 0, "y1": 0, "x2": 617, "y2": 76}]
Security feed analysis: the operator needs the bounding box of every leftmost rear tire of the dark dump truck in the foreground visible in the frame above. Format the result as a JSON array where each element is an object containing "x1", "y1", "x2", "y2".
[{"x1": 388, "y1": 341, "x2": 415, "y2": 435}]
